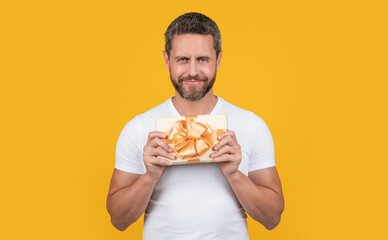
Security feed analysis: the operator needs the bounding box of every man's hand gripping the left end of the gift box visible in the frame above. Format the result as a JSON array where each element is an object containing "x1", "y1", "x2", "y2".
[{"x1": 143, "y1": 131, "x2": 176, "y2": 180}]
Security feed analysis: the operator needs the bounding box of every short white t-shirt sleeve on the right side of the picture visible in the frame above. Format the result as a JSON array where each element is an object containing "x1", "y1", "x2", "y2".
[{"x1": 248, "y1": 113, "x2": 275, "y2": 172}]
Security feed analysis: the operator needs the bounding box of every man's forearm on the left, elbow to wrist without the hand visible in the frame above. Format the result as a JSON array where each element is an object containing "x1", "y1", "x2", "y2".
[{"x1": 108, "y1": 174, "x2": 158, "y2": 231}]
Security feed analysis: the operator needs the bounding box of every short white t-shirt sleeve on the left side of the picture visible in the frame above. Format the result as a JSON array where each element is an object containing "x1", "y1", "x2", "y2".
[{"x1": 115, "y1": 117, "x2": 145, "y2": 174}]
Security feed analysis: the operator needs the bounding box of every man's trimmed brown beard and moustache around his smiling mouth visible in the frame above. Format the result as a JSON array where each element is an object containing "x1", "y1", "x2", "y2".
[{"x1": 170, "y1": 71, "x2": 217, "y2": 101}]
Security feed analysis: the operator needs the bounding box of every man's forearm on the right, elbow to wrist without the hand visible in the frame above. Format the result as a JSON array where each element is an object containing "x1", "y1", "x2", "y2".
[{"x1": 227, "y1": 171, "x2": 284, "y2": 230}]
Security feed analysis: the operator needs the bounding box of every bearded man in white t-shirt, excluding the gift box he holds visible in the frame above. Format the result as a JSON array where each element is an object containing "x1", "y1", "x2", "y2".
[{"x1": 107, "y1": 13, "x2": 284, "y2": 240}]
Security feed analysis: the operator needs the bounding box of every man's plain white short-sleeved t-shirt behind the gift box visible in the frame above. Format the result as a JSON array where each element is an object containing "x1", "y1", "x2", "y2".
[{"x1": 115, "y1": 97, "x2": 275, "y2": 240}]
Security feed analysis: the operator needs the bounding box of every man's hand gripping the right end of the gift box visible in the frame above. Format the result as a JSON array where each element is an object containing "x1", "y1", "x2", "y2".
[{"x1": 210, "y1": 131, "x2": 241, "y2": 178}]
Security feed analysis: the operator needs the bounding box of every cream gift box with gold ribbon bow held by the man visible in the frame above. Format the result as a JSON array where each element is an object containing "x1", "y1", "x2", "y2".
[{"x1": 155, "y1": 114, "x2": 228, "y2": 165}]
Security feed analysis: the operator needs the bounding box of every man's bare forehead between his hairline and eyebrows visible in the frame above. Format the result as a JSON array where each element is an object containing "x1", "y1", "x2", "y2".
[{"x1": 171, "y1": 34, "x2": 216, "y2": 55}]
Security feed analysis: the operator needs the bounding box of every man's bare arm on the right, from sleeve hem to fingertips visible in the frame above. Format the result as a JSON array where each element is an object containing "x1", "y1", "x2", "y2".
[{"x1": 211, "y1": 131, "x2": 284, "y2": 230}]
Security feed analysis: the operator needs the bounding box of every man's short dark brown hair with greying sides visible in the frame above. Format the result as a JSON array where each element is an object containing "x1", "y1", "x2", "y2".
[{"x1": 164, "y1": 12, "x2": 221, "y2": 58}]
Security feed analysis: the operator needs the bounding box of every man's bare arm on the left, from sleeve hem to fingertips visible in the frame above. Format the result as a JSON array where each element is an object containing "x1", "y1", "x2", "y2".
[{"x1": 106, "y1": 132, "x2": 175, "y2": 231}]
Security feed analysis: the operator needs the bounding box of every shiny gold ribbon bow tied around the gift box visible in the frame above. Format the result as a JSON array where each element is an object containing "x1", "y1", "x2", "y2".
[{"x1": 163, "y1": 116, "x2": 225, "y2": 162}]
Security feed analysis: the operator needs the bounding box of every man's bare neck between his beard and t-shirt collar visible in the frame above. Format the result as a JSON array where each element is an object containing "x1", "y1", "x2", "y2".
[{"x1": 171, "y1": 91, "x2": 218, "y2": 116}]
